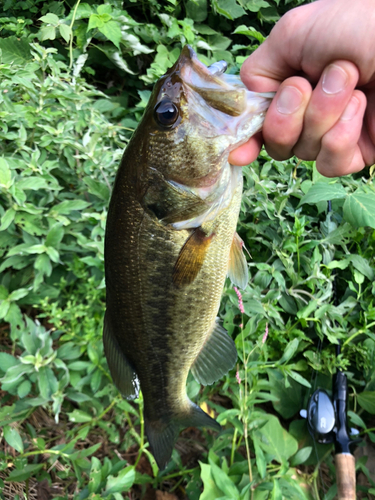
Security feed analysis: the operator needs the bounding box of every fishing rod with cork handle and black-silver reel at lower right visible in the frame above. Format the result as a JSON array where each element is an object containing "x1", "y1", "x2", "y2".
[{"x1": 301, "y1": 201, "x2": 361, "y2": 500}]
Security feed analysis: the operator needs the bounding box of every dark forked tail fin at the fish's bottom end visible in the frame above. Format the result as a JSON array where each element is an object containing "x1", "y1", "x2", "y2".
[{"x1": 145, "y1": 401, "x2": 221, "y2": 470}]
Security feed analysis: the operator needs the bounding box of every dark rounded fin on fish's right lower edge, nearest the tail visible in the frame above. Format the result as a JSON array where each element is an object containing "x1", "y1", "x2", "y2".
[{"x1": 191, "y1": 320, "x2": 237, "y2": 385}]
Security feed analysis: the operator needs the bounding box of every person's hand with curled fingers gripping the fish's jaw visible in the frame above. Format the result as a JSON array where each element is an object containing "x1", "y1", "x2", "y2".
[{"x1": 229, "y1": 0, "x2": 375, "y2": 177}]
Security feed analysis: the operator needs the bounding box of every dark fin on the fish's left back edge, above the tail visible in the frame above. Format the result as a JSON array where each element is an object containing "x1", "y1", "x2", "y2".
[{"x1": 103, "y1": 313, "x2": 139, "y2": 399}]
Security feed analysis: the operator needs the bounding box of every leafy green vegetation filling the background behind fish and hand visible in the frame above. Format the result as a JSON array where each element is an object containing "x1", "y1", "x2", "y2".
[{"x1": 0, "y1": 0, "x2": 375, "y2": 500}]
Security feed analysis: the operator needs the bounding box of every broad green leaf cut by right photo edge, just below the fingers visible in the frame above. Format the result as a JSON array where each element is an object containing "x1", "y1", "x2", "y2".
[{"x1": 343, "y1": 189, "x2": 375, "y2": 228}]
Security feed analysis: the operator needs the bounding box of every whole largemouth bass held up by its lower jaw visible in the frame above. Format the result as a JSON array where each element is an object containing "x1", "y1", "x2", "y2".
[{"x1": 103, "y1": 46, "x2": 272, "y2": 469}]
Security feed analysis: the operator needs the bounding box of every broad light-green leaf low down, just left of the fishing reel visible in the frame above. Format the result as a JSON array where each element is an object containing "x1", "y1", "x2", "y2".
[{"x1": 254, "y1": 414, "x2": 298, "y2": 464}]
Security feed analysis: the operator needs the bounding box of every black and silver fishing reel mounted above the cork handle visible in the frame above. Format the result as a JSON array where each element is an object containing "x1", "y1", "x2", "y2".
[{"x1": 300, "y1": 371, "x2": 361, "y2": 454}]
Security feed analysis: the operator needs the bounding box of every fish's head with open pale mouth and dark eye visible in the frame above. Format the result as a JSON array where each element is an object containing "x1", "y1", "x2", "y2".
[{"x1": 140, "y1": 45, "x2": 271, "y2": 189}]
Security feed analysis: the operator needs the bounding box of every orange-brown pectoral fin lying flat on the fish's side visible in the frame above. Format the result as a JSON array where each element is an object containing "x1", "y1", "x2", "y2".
[{"x1": 173, "y1": 228, "x2": 214, "y2": 286}]
